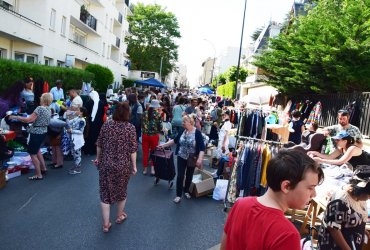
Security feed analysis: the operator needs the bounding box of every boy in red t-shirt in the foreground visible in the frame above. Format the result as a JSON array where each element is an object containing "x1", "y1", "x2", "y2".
[{"x1": 221, "y1": 150, "x2": 324, "y2": 250}]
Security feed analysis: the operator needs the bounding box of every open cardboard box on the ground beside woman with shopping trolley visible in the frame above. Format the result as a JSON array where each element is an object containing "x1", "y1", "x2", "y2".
[{"x1": 189, "y1": 168, "x2": 215, "y2": 197}]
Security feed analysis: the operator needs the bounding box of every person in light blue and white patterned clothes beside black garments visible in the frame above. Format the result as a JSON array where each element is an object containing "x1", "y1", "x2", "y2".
[{"x1": 67, "y1": 107, "x2": 87, "y2": 174}]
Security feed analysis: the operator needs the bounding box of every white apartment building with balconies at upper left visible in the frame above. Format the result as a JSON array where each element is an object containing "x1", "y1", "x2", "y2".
[{"x1": 0, "y1": 0, "x2": 132, "y2": 83}]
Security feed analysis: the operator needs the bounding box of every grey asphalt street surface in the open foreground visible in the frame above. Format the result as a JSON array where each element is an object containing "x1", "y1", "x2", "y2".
[{"x1": 0, "y1": 148, "x2": 225, "y2": 250}]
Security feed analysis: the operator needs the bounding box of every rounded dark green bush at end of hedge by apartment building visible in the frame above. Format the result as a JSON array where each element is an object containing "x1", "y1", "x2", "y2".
[{"x1": 85, "y1": 64, "x2": 114, "y2": 93}]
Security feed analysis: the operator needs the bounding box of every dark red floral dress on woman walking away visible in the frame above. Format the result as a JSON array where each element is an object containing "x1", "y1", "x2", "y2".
[{"x1": 96, "y1": 120, "x2": 137, "y2": 204}]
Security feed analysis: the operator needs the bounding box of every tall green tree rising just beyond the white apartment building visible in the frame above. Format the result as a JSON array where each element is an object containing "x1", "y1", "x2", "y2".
[{"x1": 126, "y1": 3, "x2": 181, "y2": 81}]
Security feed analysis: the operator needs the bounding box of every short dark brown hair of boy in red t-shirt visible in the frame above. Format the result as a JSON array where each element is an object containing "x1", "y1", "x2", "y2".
[{"x1": 266, "y1": 149, "x2": 324, "y2": 192}]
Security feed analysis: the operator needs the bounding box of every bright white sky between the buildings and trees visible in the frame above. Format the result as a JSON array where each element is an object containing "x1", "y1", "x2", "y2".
[{"x1": 130, "y1": 0, "x2": 294, "y2": 86}]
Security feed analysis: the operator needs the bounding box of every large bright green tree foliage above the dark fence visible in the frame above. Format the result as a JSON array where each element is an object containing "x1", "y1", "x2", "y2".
[{"x1": 254, "y1": 0, "x2": 370, "y2": 93}]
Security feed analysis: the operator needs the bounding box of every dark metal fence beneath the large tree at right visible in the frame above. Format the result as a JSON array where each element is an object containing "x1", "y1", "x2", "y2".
[{"x1": 289, "y1": 92, "x2": 370, "y2": 137}]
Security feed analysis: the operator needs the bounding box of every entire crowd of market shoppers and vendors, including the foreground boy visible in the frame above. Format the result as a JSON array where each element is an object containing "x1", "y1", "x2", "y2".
[{"x1": 0, "y1": 77, "x2": 370, "y2": 249}]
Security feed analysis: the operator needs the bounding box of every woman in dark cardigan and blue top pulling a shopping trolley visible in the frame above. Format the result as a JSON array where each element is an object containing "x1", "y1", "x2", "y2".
[{"x1": 158, "y1": 114, "x2": 205, "y2": 203}]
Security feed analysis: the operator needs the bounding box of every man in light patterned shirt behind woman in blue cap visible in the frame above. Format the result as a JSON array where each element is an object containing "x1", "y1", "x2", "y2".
[{"x1": 322, "y1": 109, "x2": 363, "y2": 148}]
